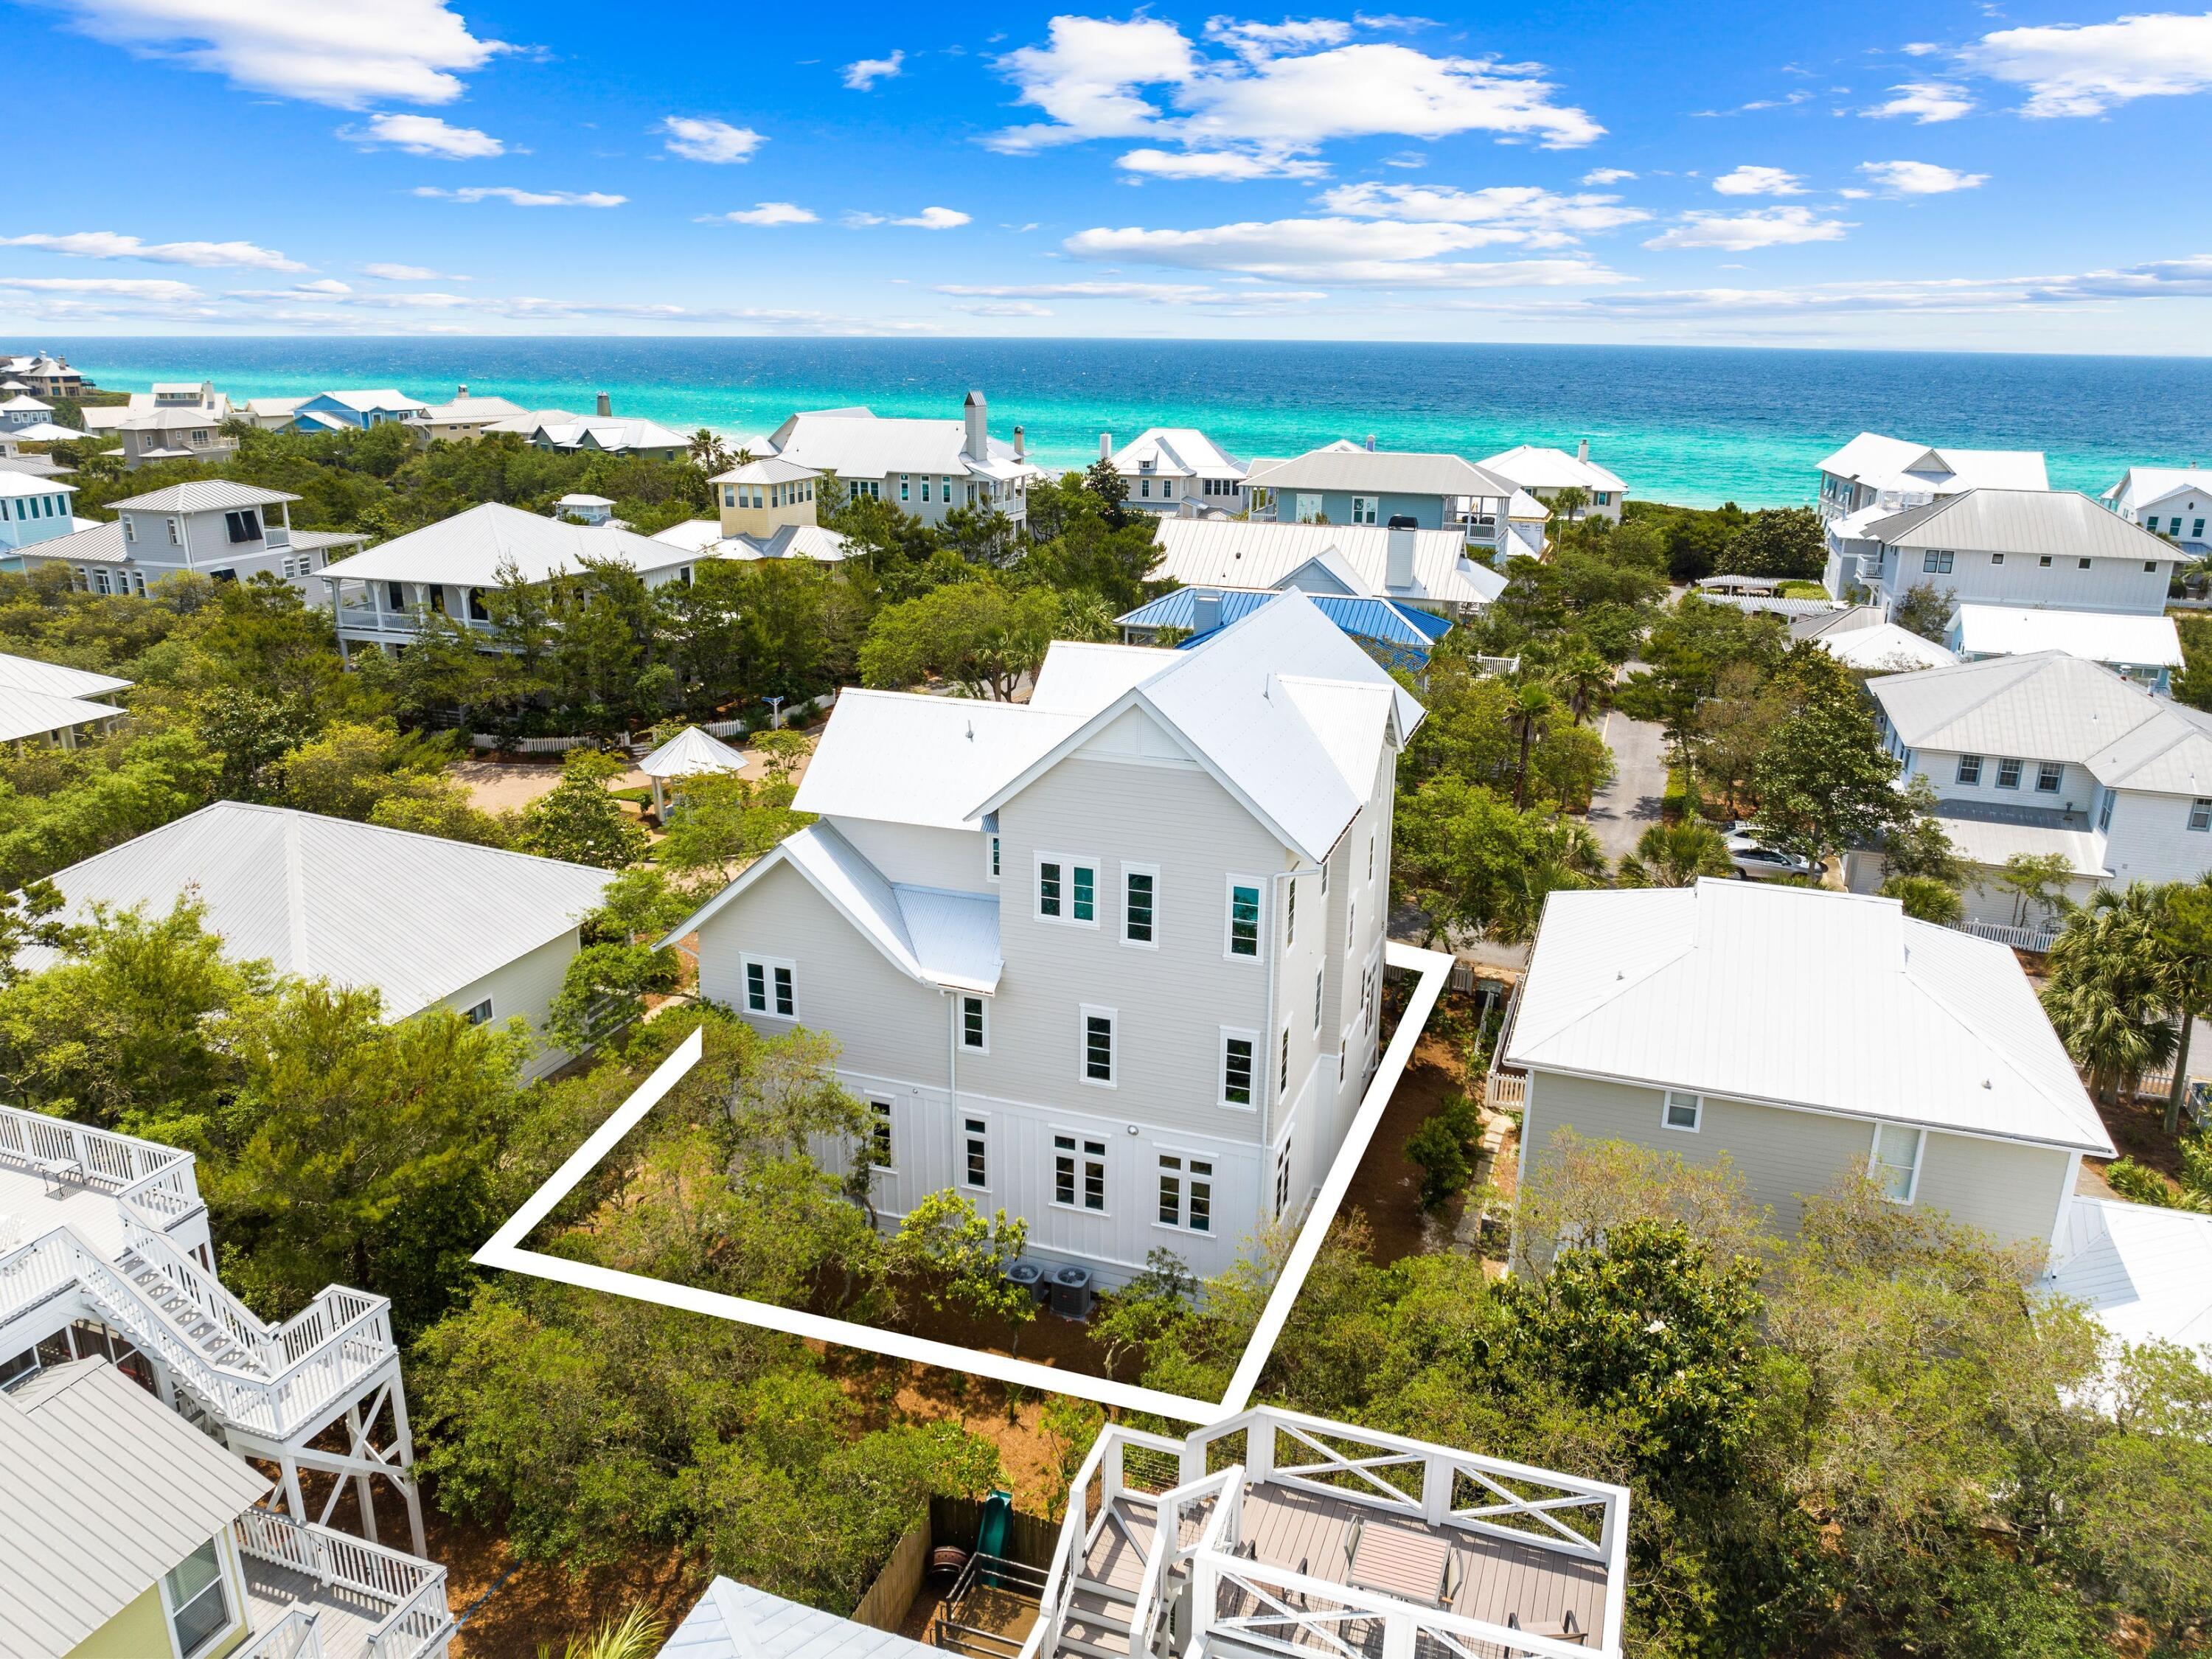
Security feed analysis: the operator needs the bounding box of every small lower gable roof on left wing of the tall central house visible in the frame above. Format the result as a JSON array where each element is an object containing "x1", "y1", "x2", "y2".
[{"x1": 661, "y1": 823, "x2": 1004, "y2": 995}]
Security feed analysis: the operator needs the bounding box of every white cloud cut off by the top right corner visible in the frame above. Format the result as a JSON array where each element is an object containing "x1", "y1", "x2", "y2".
[{"x1": 1960, "y1": 11, "x2": 2212, "y2": 117}]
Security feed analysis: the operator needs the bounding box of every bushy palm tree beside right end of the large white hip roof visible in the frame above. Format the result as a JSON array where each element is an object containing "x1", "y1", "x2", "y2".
[{"x1": 2042, "y1": 883, "x2": 2179, "y2": 1102}]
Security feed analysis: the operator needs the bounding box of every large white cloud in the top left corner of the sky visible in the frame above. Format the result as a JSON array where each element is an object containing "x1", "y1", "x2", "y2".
[{"x1": 29, "y1": 0, "x2": 511, "y2": 108}]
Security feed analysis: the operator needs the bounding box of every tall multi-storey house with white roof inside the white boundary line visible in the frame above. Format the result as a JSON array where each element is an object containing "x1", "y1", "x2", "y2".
[{"x1": 670, "y1": 593, "x2": 1420, "y2": 1285}]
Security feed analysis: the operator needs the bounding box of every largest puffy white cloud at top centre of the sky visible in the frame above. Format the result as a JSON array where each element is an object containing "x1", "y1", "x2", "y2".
[{"x1": 984, "y1": 15, "x2": 1604, "y2": 167}]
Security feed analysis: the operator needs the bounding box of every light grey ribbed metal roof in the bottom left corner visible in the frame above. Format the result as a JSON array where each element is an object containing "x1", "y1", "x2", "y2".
[{"x1": 0, "y1": 1360, "x2": 270, "y2": 1659}]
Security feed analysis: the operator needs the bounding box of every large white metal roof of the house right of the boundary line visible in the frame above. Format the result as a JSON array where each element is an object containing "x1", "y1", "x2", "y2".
[{"x1": 1506, "y1": 878, "x2": 2112, "y2": 1157}]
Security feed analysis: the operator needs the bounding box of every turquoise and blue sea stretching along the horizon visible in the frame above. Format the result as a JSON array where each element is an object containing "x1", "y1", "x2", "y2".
[{"x1": 47, "y1": 336, "x2": 2212, "y2": 507}]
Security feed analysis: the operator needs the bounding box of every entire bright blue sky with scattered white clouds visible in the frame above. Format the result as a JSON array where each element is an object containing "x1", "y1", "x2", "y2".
[{"x1": 0, "y1": 0, "x2": 2212, "y2": 356}]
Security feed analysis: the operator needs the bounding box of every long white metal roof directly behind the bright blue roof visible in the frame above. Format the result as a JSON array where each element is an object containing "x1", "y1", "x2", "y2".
[{"x1": 1152, "y1": 518, "x2": 1506, "y2": 604}]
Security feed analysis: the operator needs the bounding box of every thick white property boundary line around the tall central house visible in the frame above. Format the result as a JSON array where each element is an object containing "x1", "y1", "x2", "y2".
[{"x1": 476, "y1": 945, "x2": 1451, "y2": 1425}]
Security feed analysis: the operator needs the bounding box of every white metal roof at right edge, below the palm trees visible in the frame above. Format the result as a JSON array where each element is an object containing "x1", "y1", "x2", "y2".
[{"x1": 2044, "y1": 1194, "x2": 2212, "y2": 1363}]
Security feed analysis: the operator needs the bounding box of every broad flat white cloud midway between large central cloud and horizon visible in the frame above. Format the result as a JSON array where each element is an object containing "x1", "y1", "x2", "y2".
[{"x1": 1064, "y1": 217, "x2": 1626, "y2": 288}]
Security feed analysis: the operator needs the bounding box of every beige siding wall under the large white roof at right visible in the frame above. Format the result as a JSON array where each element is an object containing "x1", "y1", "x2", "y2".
[{"x1": 1522, "y1": 1071, "x2": 2075, "y2": 1245}]
